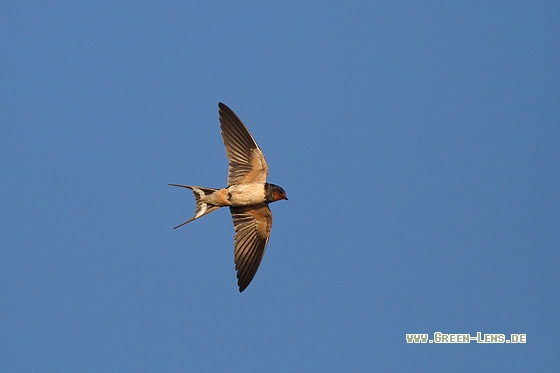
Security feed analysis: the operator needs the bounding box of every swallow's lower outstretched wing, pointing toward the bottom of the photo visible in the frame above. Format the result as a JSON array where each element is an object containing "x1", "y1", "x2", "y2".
[{"x1": 230, "y1": 204, "x2": 272, "y2": 292}]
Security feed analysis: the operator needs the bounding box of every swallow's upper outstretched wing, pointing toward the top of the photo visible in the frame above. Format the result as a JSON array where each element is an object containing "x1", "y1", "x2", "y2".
[{"x1": 218, "y1": 102, "x2": 268, "y2": 186}]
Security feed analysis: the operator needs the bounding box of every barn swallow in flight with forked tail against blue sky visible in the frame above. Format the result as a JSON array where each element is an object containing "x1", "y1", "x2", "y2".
[{"x1": 169, "y1": 102, "x2": 288, "y2": 292}]
